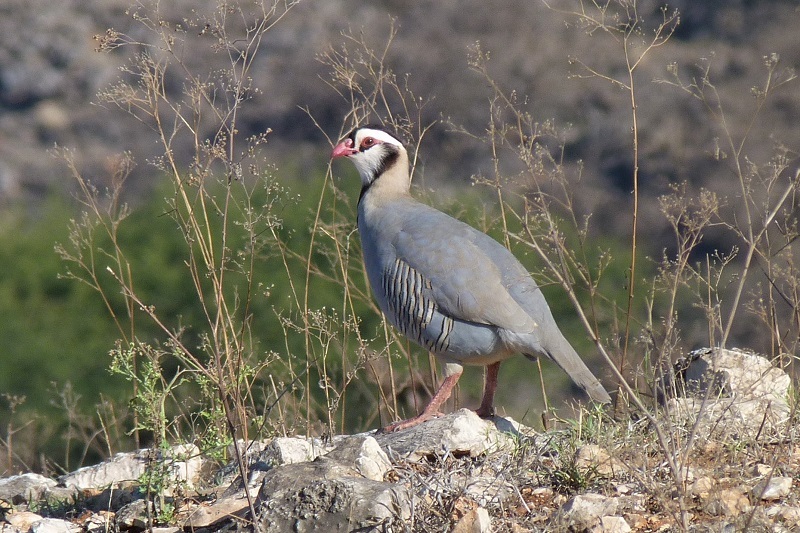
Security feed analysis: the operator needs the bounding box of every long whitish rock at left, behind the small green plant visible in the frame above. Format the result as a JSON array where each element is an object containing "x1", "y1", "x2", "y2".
[{"x1": 59, "y1": 444, "x2": 203, "y2": 495}]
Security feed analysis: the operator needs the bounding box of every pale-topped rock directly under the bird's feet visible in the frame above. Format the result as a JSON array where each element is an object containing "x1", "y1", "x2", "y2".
[{"x1": 374, "y1": 409, "x2": 519, "y2": 461}]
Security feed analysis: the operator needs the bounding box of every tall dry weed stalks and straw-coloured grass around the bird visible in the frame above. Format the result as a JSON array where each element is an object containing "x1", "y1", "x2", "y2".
[{"x1": 1, "y1": 1, "x2": 800, "y2": 530}]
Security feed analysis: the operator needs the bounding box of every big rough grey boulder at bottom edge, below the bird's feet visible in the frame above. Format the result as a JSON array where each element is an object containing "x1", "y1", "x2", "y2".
[{"x1": 257, "y1": 457, "x2": 412, "y2": 533}]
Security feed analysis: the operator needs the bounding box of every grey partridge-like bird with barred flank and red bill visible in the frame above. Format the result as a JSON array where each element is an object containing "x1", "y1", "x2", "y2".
[{"x1": 331, "y1": 125, "x2": 611, "y2": 432}]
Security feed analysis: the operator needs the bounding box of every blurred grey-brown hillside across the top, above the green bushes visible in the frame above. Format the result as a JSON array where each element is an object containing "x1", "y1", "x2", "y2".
[{"x1": 0, "y1": 0, "x2": 800, "y2": 217}]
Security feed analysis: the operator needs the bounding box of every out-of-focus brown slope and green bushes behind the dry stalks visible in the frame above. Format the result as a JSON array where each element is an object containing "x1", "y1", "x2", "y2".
[{"x1": 0, "y1": 0, "x2": 800, "y2": 474}]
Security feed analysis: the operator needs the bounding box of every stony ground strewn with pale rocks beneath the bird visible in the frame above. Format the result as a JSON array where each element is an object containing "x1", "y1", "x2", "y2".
[{"x1": 0, "y1": 350, "x2": 800, "y2": 533}]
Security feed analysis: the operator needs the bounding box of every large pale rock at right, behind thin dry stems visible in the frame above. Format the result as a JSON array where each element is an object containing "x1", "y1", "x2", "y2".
[{"x1": 665, "y1": 349, "x2": 791, "y2": 436}]
